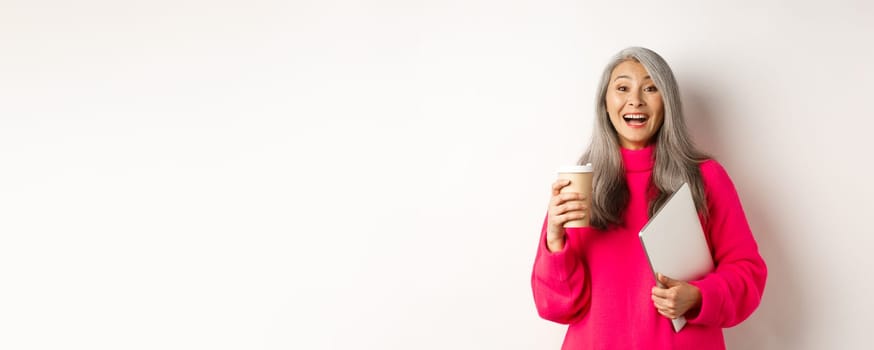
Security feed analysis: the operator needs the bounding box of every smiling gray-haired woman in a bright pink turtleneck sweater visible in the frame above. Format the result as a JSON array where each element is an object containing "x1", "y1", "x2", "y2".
[{"x1": 531, "y1": 47, "x2": 767, "y2": 349}]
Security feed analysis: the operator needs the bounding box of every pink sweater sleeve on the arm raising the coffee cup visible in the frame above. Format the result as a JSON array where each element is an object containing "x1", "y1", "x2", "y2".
[{"x1": 531, "y1": 213, "x2": 591, "y2": 324}]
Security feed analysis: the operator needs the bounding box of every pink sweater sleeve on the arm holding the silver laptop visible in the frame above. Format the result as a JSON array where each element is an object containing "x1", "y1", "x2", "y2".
[{"x1": 687, "y1": 160, "x2": 768, "y2": 327}]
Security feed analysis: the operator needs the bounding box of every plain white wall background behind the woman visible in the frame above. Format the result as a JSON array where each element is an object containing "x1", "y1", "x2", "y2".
[{"x1": 0, "y1": 0, "x2": 874, "y2": 349}]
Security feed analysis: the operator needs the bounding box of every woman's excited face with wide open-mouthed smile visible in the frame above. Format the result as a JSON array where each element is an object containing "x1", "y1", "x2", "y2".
[{"x1": 604, "y1": 60, "x2": 665, "y2": 149}]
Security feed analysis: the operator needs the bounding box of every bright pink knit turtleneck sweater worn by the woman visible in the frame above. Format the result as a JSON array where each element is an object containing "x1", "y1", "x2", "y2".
[{"x1": 531, "y1": 146, "x2": 767, "y2": 350}]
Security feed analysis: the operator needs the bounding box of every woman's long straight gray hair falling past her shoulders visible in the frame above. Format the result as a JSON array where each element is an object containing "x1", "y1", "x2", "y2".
[{"x1": 579, "y1": 47, "x2": 709, "y2": 230}]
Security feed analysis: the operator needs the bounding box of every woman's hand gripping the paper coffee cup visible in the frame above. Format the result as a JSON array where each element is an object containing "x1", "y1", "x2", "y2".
[{"x1": 546, "y1": 179, "x2": 588, "y2": 252}]
